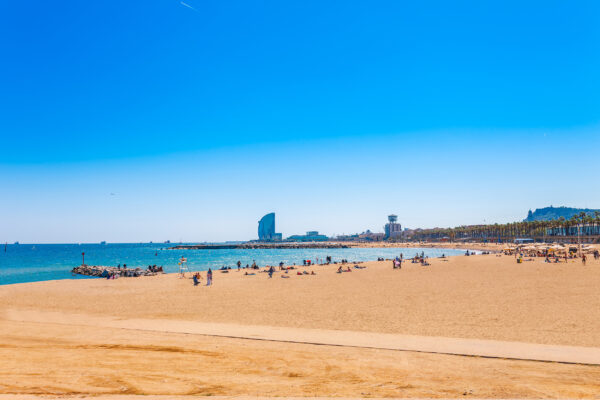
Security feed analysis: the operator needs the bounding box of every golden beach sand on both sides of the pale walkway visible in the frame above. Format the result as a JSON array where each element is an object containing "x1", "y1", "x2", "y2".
[{"x1": 0, "y1": 255, "x2": 600, "y2": 398}]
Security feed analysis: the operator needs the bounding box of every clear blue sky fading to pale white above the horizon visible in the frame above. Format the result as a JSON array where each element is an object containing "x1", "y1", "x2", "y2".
[{"x1": 0, "y1": 0, "x2": 600, "y2": 243}]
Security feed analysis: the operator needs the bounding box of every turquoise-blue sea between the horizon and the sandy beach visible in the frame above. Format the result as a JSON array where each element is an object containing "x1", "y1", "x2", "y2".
[{"x1": 0, "y1": 243, "x2": 465, "y2": 285}]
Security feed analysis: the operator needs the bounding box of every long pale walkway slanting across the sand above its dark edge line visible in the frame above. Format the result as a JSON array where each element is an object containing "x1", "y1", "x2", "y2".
[{"x1": 7, "y1": 310, "x2": 600, "y2": 365}]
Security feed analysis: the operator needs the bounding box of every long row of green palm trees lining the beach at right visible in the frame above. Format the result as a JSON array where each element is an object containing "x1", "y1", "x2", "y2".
[{"x1": 403, "y1": 211, "x2": 600, "y2": 241}]
